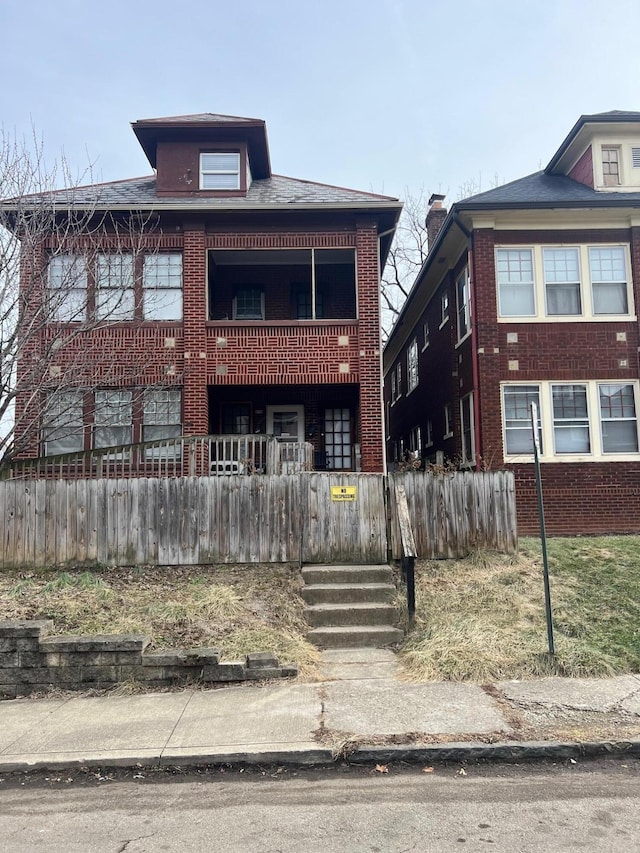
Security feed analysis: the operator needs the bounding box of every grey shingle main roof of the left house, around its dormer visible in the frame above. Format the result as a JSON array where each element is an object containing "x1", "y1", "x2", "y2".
[{"x1": 5, "y1": 175, "x2": 400, "y2": 210}]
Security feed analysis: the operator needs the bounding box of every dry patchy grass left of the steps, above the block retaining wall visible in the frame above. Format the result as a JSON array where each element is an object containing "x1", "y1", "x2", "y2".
[{"x1": 0, "y1": 565, "x2": 319, "y2": 675}]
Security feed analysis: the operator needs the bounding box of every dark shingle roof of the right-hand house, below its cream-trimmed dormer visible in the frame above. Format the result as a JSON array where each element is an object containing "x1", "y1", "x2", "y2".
[{"x1": 455, "y1": 172, "x2": 640, "y2": 210}]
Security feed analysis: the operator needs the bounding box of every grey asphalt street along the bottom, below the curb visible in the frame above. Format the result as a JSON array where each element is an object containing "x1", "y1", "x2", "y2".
[{"x1": 0, "y1": 761, "x2": 640, "y2": 853}]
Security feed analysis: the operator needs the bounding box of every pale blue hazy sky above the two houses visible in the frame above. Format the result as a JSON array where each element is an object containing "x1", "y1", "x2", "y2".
[{"x1": 0, "y1": 0, "x2": 640, "y2": 200}]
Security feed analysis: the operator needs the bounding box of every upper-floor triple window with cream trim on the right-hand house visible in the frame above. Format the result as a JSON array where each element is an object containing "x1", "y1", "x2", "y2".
[{"x1": 496, "y1": 244, "x2": 634, "y2": 322}]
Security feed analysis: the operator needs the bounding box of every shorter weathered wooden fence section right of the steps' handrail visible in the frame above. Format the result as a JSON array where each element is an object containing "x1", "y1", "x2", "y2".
[{"x1": 389, "y1": 471, "x2": 518, "y2": 559}]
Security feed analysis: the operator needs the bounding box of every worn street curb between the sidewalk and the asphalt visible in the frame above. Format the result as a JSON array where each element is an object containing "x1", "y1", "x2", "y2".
[{"x1": 0, "y1": 738, "x2": 640, "y2": 773}]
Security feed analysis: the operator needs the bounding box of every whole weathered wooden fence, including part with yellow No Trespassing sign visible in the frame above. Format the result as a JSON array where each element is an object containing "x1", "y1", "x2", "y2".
[{"x1": 0, "y1": 472, "x2": 516, "y2": 567}]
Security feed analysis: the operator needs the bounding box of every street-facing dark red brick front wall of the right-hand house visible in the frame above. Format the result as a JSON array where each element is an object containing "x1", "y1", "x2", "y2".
[{"x1": 474, "y1": 228, "x2": 640, "y2": 535}]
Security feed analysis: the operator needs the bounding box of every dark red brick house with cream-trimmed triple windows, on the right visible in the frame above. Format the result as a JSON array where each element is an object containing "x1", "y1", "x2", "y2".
[{"x1": 384, "y1": 111, "x2": 640, "y2": 534}]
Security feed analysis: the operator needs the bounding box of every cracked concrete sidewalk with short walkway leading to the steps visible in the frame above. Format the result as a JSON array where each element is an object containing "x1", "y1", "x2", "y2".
[{"x1": 0, "y1": 650, "x2": 640, "y2": 772}]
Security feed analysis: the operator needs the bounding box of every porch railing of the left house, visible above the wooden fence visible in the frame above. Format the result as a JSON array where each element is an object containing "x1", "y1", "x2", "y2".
[{"x1": 5, "y1": 435, "x2": 313, "y2": 480}]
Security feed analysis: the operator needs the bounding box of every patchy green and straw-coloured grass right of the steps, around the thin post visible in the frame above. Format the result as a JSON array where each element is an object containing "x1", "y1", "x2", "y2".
[{"x1": 401, "y1": 536, "x2": 640, "y2": 682}]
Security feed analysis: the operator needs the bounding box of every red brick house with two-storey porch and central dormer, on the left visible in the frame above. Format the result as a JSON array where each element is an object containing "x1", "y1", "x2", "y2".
[{"x1": 10, "y1": 113, "x2": 401, "y2": 471}]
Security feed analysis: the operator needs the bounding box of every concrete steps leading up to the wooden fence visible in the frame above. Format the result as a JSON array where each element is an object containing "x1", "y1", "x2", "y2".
[{"x1": 302, "y1": 566, "x2": 403, "y2": 649}]
